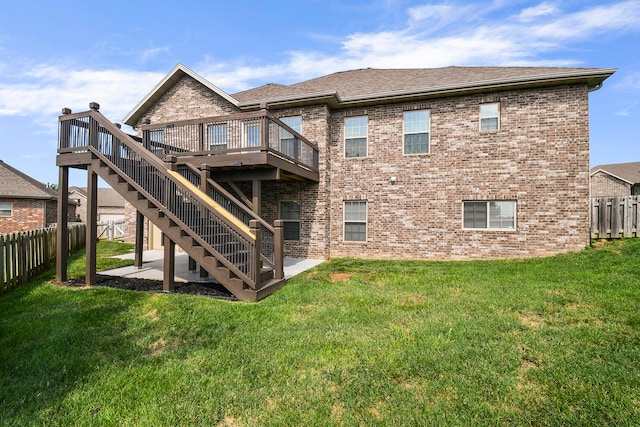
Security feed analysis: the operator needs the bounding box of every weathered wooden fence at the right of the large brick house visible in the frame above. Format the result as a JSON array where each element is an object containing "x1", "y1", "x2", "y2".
[{"x1": 591, "y1": 196, "x2": 640, "y2": 239}]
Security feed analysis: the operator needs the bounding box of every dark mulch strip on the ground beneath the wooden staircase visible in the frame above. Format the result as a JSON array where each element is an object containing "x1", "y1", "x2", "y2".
[{"x1": 63, "y1": 274, "x2": 237, "y2": 301}]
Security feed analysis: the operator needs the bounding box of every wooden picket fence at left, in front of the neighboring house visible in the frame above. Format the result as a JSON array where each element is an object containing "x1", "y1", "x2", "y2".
[{"x1": 0, "y1": 224, "x2": 86, "y2": 293}]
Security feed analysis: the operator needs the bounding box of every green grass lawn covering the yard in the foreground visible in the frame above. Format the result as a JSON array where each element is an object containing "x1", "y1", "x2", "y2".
[{"x1": 0, "y1": 239, "x2": 640, "y2": 426}]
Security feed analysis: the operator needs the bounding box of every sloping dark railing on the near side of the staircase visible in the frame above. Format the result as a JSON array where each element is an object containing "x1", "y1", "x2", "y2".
[{"x1": 58, "y1": 110, "x2": 272, "y2": 286}]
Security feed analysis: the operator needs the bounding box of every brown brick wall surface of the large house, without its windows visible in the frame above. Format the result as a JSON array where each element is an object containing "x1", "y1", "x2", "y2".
[{"x1": 132, "y1": 78, "x2": 589, "y2": 259}]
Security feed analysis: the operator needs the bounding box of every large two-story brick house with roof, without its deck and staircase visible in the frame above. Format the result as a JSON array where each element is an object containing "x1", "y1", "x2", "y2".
[{"x1": 117, "y1": 65, "x2": 615, "y2": 259}]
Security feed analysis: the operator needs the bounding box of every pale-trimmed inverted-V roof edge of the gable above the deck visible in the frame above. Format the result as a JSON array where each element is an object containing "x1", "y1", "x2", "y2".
[{"x1": 123, "y1": 64, "x2": 238, "y2": 126}]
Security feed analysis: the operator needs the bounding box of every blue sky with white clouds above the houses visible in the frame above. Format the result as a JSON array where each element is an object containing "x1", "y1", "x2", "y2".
[{"x1": 0, "y1": 0, "x2": 640, "y2": 186}]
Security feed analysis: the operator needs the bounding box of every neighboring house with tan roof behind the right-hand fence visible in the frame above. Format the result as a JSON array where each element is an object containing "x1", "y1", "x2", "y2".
[{"x1": 591, "y1": 162, "x2": 640, "y2": 197}]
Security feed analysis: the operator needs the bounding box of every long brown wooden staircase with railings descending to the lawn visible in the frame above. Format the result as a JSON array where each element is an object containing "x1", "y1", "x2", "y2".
[{"x1": 60, "y1": 111, "x2": 285, "y2": 301}]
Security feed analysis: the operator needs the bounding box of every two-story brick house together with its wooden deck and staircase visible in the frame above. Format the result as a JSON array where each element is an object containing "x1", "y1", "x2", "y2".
[{"x1": 57, "y1": 64, "x2": 615, "y2": 299}]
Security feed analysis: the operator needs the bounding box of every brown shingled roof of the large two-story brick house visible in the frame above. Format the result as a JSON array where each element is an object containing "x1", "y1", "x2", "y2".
[{"x1": 124, "y1": 64, "x2": 616, "y2": 126}]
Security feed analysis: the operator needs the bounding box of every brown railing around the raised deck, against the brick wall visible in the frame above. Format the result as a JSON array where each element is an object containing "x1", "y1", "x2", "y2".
[{"x1": 141, "y1": 110, "x2": 318, "y2": 172}]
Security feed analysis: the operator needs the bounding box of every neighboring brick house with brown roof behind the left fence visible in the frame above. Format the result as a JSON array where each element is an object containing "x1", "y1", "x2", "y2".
[{"x1": 0, "y1": 160, "x2": 75, "y2": 233}]
